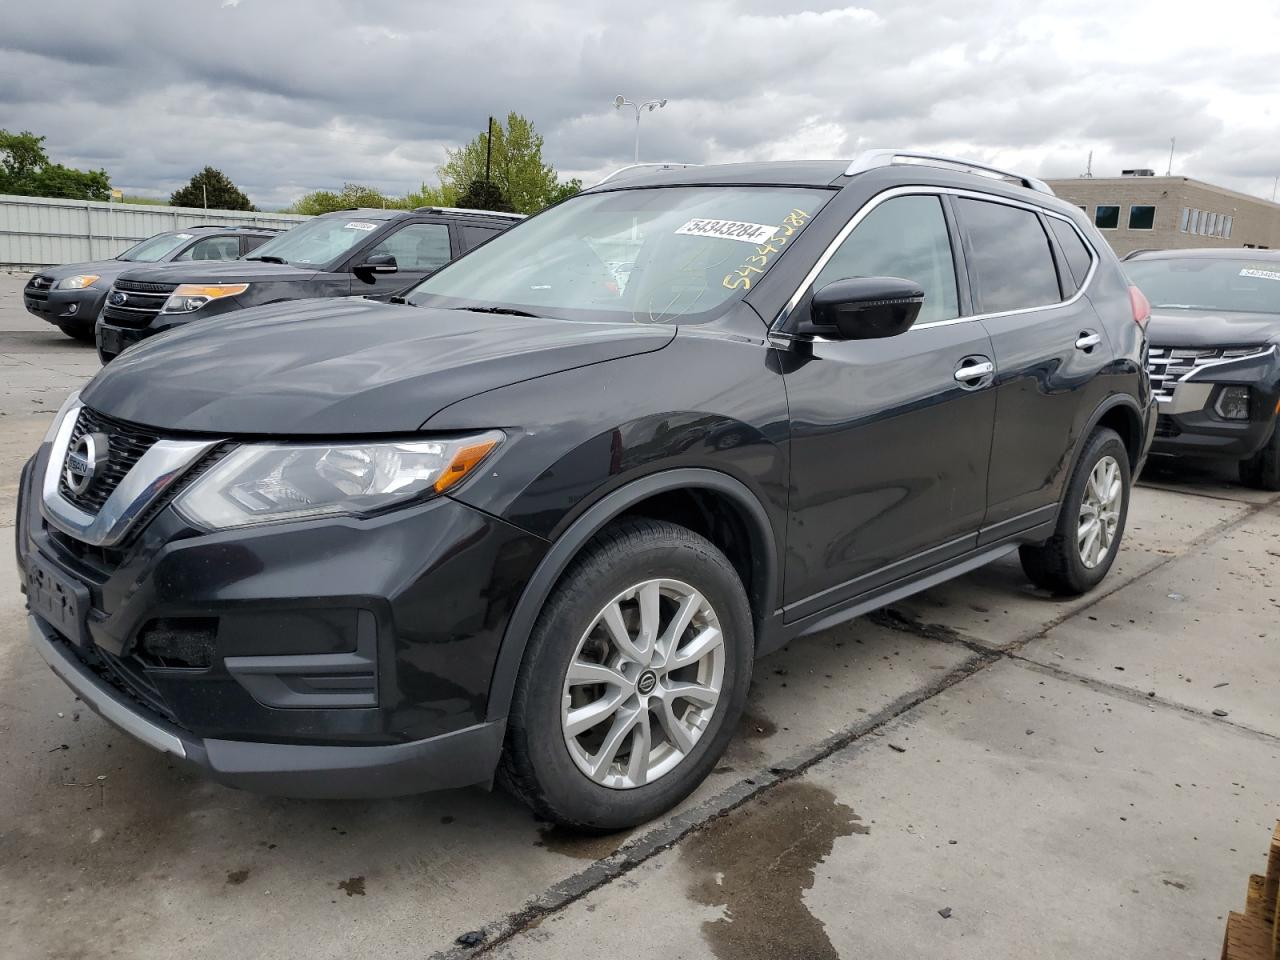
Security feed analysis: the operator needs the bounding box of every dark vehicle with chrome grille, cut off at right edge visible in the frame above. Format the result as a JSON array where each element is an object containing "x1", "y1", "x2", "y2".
[{"x1": 1124, "y1": 250, "x2": 1280, "y2": 490}]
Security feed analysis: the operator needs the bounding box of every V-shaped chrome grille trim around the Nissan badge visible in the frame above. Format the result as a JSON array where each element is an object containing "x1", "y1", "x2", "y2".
[{"x1": 40, "y1": 403, "x2": 221, "y2": 547}]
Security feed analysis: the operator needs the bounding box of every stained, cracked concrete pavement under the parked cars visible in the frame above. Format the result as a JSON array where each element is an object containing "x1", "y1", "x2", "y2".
[{"x1": 0, "y1": 274, "x2": 1280, "y2": 960}]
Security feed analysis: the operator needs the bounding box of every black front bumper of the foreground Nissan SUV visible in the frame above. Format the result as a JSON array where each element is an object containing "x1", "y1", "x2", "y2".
[{"x1": 17, "y1": 445, "x2": 545, "y2": 797}]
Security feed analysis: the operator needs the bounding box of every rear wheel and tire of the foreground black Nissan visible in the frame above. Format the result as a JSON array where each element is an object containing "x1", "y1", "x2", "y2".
[{"x1": 1018, "y1": 428, "x2": 1130, "y2": 596}]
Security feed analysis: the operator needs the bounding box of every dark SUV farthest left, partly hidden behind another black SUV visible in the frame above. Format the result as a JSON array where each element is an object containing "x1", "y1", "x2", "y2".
[{"x1": 22, "y1": 225, "x2": 280, "y2": 343}]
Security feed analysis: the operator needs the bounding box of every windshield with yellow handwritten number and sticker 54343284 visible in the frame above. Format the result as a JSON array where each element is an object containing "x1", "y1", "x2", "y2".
[{"x1": 407, "y1": 187, "x2": 831, "y2": 324}]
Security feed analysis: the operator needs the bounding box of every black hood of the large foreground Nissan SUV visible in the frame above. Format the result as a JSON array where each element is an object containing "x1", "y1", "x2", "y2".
[{"x1": 81, "y1": 297, "x2": 676, "y2": 436}]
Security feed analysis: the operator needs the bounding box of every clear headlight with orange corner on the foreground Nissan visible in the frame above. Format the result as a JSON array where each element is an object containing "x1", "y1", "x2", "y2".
[{"x1": 177, "y1": 430, "x2": 504, "y2": 530}]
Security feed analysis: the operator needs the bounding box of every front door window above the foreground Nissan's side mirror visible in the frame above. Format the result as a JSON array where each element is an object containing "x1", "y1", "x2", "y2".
[{"x1": 813, "y1": 196, "x2": 960, "y2": 324}]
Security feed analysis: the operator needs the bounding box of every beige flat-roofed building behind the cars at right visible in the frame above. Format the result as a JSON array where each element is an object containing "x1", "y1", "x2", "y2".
[{"x1": 1048, "y1": 170, "x2": 1280, "y2": 256}]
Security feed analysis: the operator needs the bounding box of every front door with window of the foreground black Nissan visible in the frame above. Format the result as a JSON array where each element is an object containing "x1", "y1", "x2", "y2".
[{"x1": 785, "y1": 193, "x2": 996, "y2": 620}]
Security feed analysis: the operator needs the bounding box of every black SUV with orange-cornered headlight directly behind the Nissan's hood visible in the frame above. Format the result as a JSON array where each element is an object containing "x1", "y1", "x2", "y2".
[{"x1": 97, "y1": 207, "x2": 521, "y2": 364}]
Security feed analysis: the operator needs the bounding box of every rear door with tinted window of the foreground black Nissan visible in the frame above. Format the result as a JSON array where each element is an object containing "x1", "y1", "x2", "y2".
[{"x1": 952, "y1": 195, "x2": 1111, "y2": 541}]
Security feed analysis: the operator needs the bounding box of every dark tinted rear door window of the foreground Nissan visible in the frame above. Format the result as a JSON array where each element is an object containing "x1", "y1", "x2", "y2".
[{"x1": 956, "y1": 198, "x2": 1062, "y2": 314}]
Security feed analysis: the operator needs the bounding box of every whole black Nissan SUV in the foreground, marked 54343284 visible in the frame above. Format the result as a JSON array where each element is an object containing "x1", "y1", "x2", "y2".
[{"x1": 18, "y1": 151, "x2": 1155, "y2": 829}]
